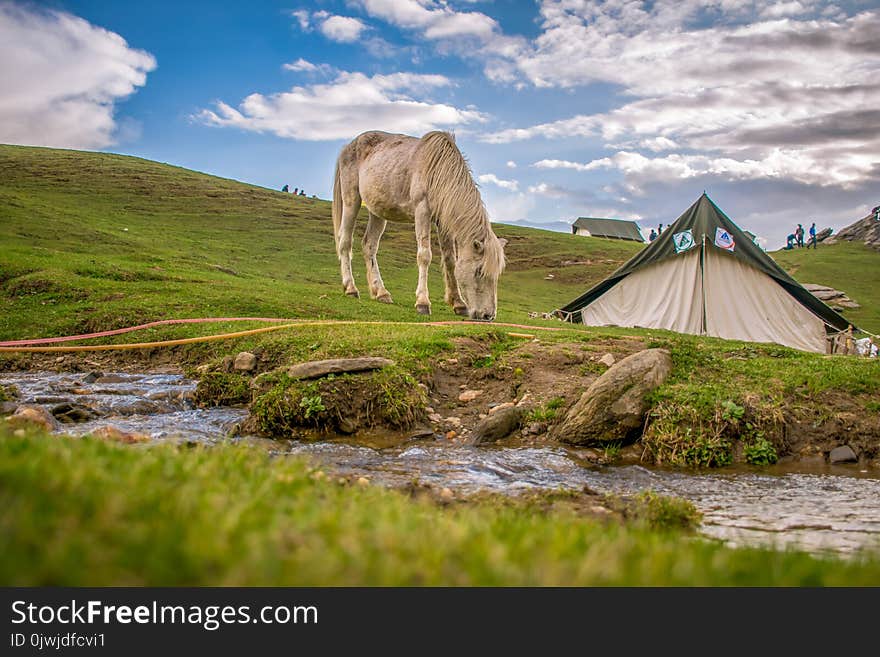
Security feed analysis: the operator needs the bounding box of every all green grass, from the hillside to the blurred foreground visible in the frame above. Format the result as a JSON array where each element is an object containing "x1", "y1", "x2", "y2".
[{"x1": 0, "y1": 146, "x2": 880, "y2": 586}]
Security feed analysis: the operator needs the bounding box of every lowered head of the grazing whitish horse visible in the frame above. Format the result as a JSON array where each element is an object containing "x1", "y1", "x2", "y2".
[{"x1": 455, "y1": 231, "x2": 507, "y2": 322}]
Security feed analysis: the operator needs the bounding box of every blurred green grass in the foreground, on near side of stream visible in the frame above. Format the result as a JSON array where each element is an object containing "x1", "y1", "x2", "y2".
[{"x1": 0, "y1": 430, "x2": 880, "y2": 586}]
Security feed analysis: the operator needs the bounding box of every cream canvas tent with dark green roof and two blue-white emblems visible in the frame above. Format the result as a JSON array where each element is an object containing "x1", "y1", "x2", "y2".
[{"x1": 555, "y1": 193, "x2": 849, "y2": 353}]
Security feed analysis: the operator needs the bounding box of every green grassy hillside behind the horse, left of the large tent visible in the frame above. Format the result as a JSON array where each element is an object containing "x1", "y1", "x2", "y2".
[{"x1": 0, "y1": 146, "x2": 640, "y2": 339}]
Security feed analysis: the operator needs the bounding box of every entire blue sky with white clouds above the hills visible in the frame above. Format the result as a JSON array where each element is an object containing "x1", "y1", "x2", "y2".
[{"x1": 0, "y1": 0, "x2": 880, "y2": 250}]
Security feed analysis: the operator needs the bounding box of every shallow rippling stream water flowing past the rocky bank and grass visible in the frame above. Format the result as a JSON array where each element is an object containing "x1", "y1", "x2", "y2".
[{"x1": 0, "y1": 372, "x2": 880, "y2": 554}]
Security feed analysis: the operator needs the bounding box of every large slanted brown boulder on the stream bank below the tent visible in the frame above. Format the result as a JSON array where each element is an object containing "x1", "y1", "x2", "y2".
[{"x1": 553, "y1": 349, "x2": 672, "y2": 445}]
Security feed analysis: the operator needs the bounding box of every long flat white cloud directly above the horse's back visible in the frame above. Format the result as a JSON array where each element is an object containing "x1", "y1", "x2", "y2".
[{"x1": 196, "y1": 71, "x2": 485, "y2": 141}]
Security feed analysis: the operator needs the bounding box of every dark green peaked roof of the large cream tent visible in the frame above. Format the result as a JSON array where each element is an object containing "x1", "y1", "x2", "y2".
[{"x1": 556, "y1": 192, "x2": 856, "y2": 331}]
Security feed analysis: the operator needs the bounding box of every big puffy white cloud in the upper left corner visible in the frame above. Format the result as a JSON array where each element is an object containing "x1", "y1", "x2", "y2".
[{"x1": 0, "y1": 3, "x2": 156, "y2": 148}]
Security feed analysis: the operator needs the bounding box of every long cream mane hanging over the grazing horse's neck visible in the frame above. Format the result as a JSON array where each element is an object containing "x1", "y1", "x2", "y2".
[{"x1": 417, "y1": 131, "x2": 504, "y2": 275}]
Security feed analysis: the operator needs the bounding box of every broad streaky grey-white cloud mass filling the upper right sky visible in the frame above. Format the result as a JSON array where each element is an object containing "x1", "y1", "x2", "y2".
[{"x1": 482, "y1": 0, "x2": 880, "y2": 186}]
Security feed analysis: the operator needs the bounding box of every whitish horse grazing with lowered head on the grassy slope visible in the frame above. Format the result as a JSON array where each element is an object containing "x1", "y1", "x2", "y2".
[{"x1": 333, "y1": 131, "x2": 506, "y2": 321}]
